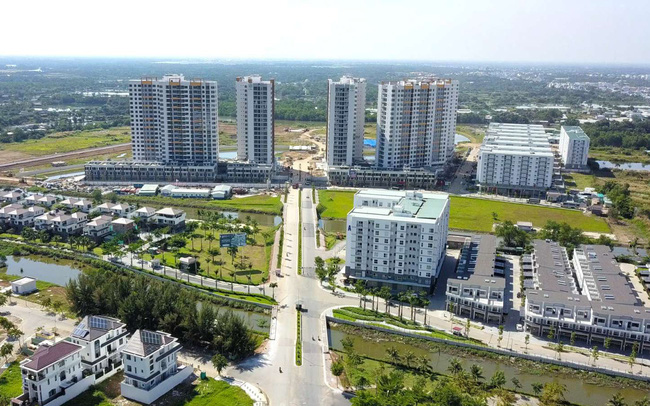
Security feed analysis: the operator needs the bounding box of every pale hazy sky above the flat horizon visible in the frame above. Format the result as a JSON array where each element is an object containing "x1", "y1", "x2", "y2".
[{"x1": 5, "y1": 0, "x2": 650, "y2": 65}]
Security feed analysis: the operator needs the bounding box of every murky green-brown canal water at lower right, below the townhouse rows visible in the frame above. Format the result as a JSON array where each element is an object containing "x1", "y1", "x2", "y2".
[{"x1": 328, "y1": 326, "x2": 647, "y2": 406}]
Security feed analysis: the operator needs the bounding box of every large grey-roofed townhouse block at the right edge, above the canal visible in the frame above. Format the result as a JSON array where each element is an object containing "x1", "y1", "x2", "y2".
[{"x1": 525, "y1": 243, "x2": 650, "y2": 351}]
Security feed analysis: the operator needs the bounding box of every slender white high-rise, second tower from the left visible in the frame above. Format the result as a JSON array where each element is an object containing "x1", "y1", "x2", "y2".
[{"x1": 235, "y1": 75, "x2": 275, "y2": 164}]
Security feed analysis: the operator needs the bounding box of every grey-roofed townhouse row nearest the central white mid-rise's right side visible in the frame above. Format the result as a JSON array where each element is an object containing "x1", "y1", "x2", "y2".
[{"x1": 446, "y1": 235, "x2": 507, "y2": 324}]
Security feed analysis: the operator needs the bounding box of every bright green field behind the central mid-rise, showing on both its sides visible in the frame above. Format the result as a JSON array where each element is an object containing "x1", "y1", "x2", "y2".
[{"x1": 318, "y1": 190, "x2": 610, "y2": 233}]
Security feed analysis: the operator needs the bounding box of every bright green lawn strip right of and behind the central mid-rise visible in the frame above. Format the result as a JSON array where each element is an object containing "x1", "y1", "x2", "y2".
[{"x1": 449, "y1": 196, "x2": 610, "y2": 233}]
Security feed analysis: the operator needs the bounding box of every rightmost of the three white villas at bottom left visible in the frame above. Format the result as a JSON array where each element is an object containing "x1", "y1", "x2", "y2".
[{"x1": 121, "y1": 330, "x2": 192, "y2": 404}]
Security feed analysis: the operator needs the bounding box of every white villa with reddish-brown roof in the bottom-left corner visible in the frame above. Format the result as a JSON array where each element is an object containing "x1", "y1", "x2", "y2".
[{"x1": 12, "y1": 341, "x2": 95, "y2": 406}]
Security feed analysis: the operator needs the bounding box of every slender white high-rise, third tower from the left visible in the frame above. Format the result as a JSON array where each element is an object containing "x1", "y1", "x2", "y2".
[{"x1": 326, "y1": 76, "x2": 366, "y2": 166}]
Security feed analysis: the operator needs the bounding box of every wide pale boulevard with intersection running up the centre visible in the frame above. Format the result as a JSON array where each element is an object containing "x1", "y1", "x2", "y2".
[{"x1": 227, "y1": 190, "x2": 358, "y2": 406}]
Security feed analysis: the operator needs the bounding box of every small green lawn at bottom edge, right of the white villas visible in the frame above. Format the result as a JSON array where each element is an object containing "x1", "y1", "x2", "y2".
[{"x1": 173, "y1": 379, "x2": 253, "y2": 406}]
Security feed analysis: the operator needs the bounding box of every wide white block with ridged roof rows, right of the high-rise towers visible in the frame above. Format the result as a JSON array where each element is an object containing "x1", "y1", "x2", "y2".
[{"x1": 476, "y1": 123, "x2": 554, "y2": 191}]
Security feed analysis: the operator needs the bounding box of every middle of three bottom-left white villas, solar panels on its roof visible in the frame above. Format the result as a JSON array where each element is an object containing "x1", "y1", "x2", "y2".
[{"x1": 70, "y1": 315, "x2": 129, "y2": 382}]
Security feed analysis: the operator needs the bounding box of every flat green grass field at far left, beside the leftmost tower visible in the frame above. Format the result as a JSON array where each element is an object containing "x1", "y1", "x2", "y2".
[{"x1": 0, "y1": 127, "x2": 131, "y2": 156}]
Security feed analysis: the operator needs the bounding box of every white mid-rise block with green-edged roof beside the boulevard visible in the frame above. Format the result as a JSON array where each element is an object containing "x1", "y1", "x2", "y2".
[{"x1": 345, "y1": 189, "x2": 449, "y2": 292}]
